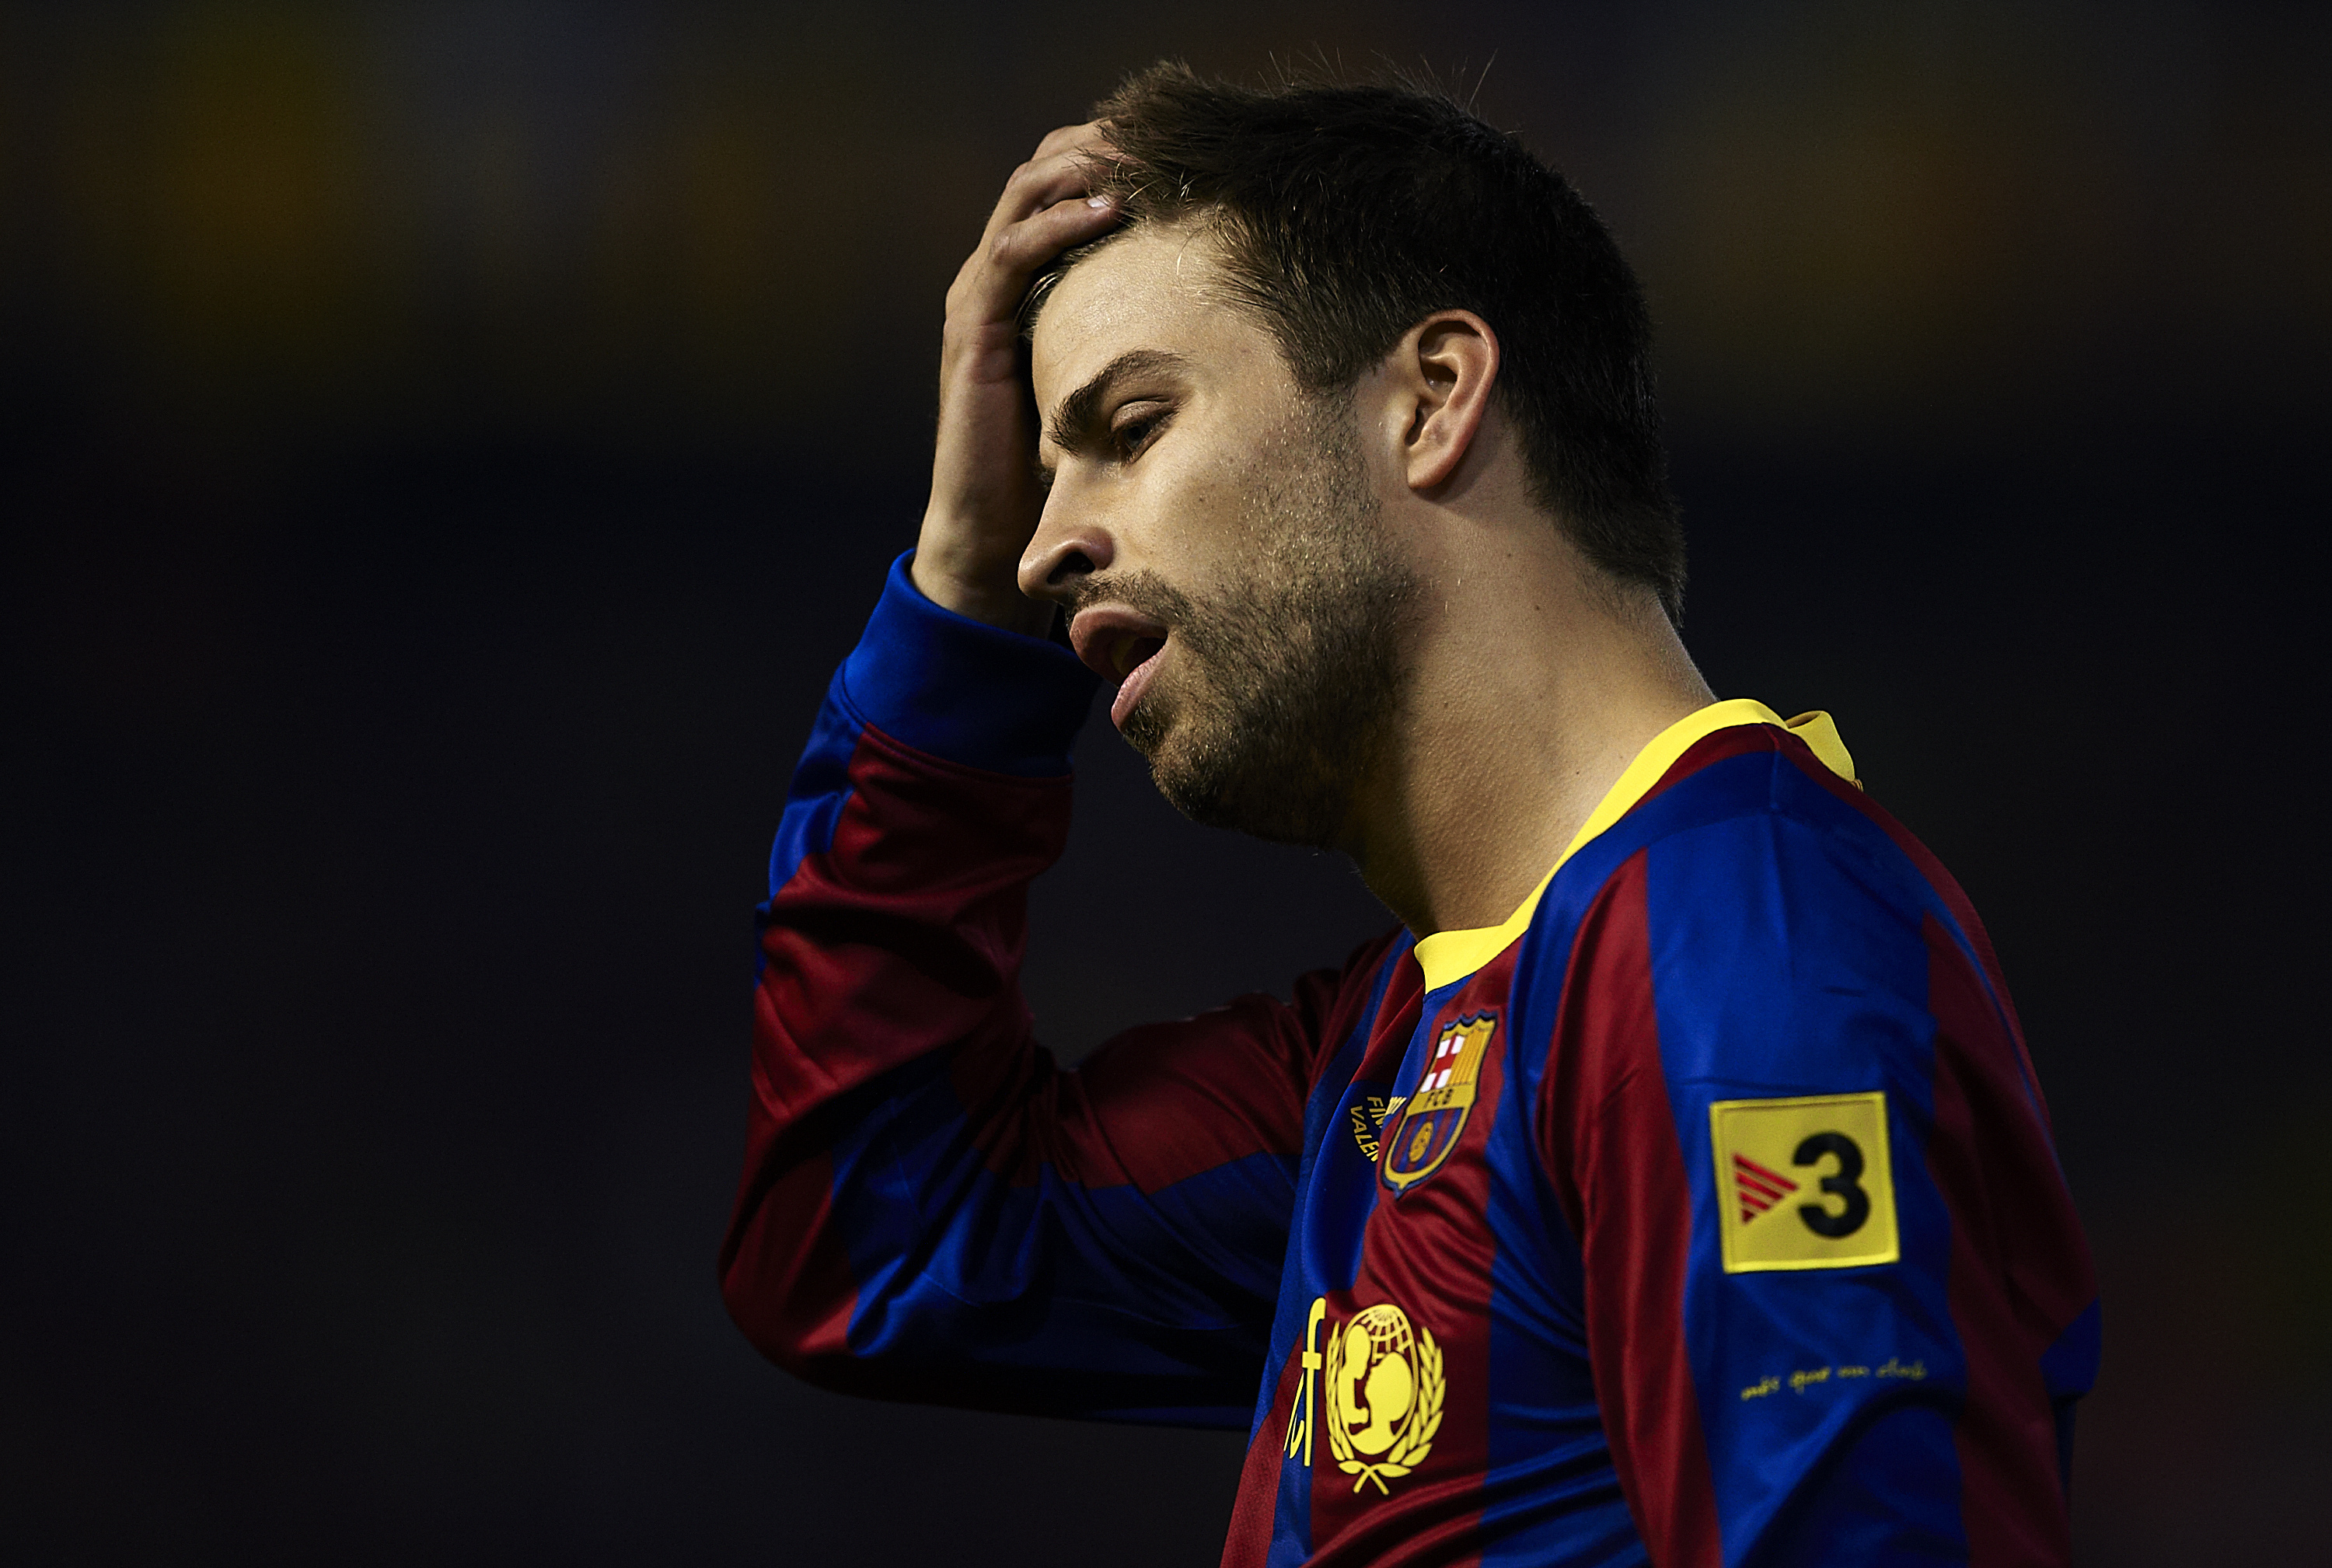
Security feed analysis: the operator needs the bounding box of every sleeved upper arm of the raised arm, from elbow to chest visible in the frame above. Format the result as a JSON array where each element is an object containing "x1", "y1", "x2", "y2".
[{"x1": 774, "y1": 942, "x2": 1371, "y2": 1426}]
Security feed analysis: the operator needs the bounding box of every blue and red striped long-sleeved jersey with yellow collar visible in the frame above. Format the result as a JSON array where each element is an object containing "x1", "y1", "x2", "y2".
[{"x1": 721, "y1": 562, "x2": 2099, "y2": 1568}]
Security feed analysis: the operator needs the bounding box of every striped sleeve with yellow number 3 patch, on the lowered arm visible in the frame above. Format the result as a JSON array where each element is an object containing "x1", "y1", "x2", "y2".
[{"x1": 1539, "y1": 730, "x2": 2096, "y2": 1568}]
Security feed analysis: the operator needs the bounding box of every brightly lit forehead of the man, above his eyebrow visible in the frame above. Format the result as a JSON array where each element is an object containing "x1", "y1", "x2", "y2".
[{"x1": 1028, "y1": 224, "x2": 1280, "y2": 413}]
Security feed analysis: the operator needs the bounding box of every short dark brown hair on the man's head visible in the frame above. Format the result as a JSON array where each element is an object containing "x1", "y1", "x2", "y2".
[{"x1": 1031, "y1": 61, "x2": 1684, "y2": 623}]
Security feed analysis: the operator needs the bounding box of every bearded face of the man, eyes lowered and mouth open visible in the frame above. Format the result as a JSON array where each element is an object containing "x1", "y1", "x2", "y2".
[{"x1": 1021, "y1": 229, "x2": 1418, "y2": 847}]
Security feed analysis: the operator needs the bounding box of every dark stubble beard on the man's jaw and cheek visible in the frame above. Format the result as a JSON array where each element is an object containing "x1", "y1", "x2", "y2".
[{"x1": 1091, "y1": 406, "x2": 1420, "y2": 850}]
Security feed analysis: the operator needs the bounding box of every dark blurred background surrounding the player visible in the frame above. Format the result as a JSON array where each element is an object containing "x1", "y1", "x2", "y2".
[{"x1": 0, "y1": 0, "x2": 2332, "y2": 1566}]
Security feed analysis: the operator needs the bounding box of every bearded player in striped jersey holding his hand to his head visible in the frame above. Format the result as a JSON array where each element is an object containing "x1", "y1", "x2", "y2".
[{"x1": 723, "y1": 68, "x2": 2096, "y2": 1563}]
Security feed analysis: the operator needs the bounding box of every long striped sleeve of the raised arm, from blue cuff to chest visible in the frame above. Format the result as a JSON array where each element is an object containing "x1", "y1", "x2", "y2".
[{"x1": 721, "y1": 560, "x2": 1339, "y2": 1426}]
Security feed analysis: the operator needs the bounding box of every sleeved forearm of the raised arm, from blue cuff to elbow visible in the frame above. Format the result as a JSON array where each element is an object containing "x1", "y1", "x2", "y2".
[{"x1": 723, "y1": 548, "x2": 1091, "y2": 1372}]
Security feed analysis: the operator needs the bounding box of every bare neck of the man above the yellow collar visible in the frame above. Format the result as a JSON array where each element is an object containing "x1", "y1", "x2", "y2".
[{"x1": 1346, "y1": 532, "x2": 1712, "y2": 936}]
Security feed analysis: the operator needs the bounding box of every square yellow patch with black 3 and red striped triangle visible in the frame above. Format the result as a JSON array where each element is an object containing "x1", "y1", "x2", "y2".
[{"x1": 1709, "y1": 1090, "x2": 1903, "y2": 1274}]
